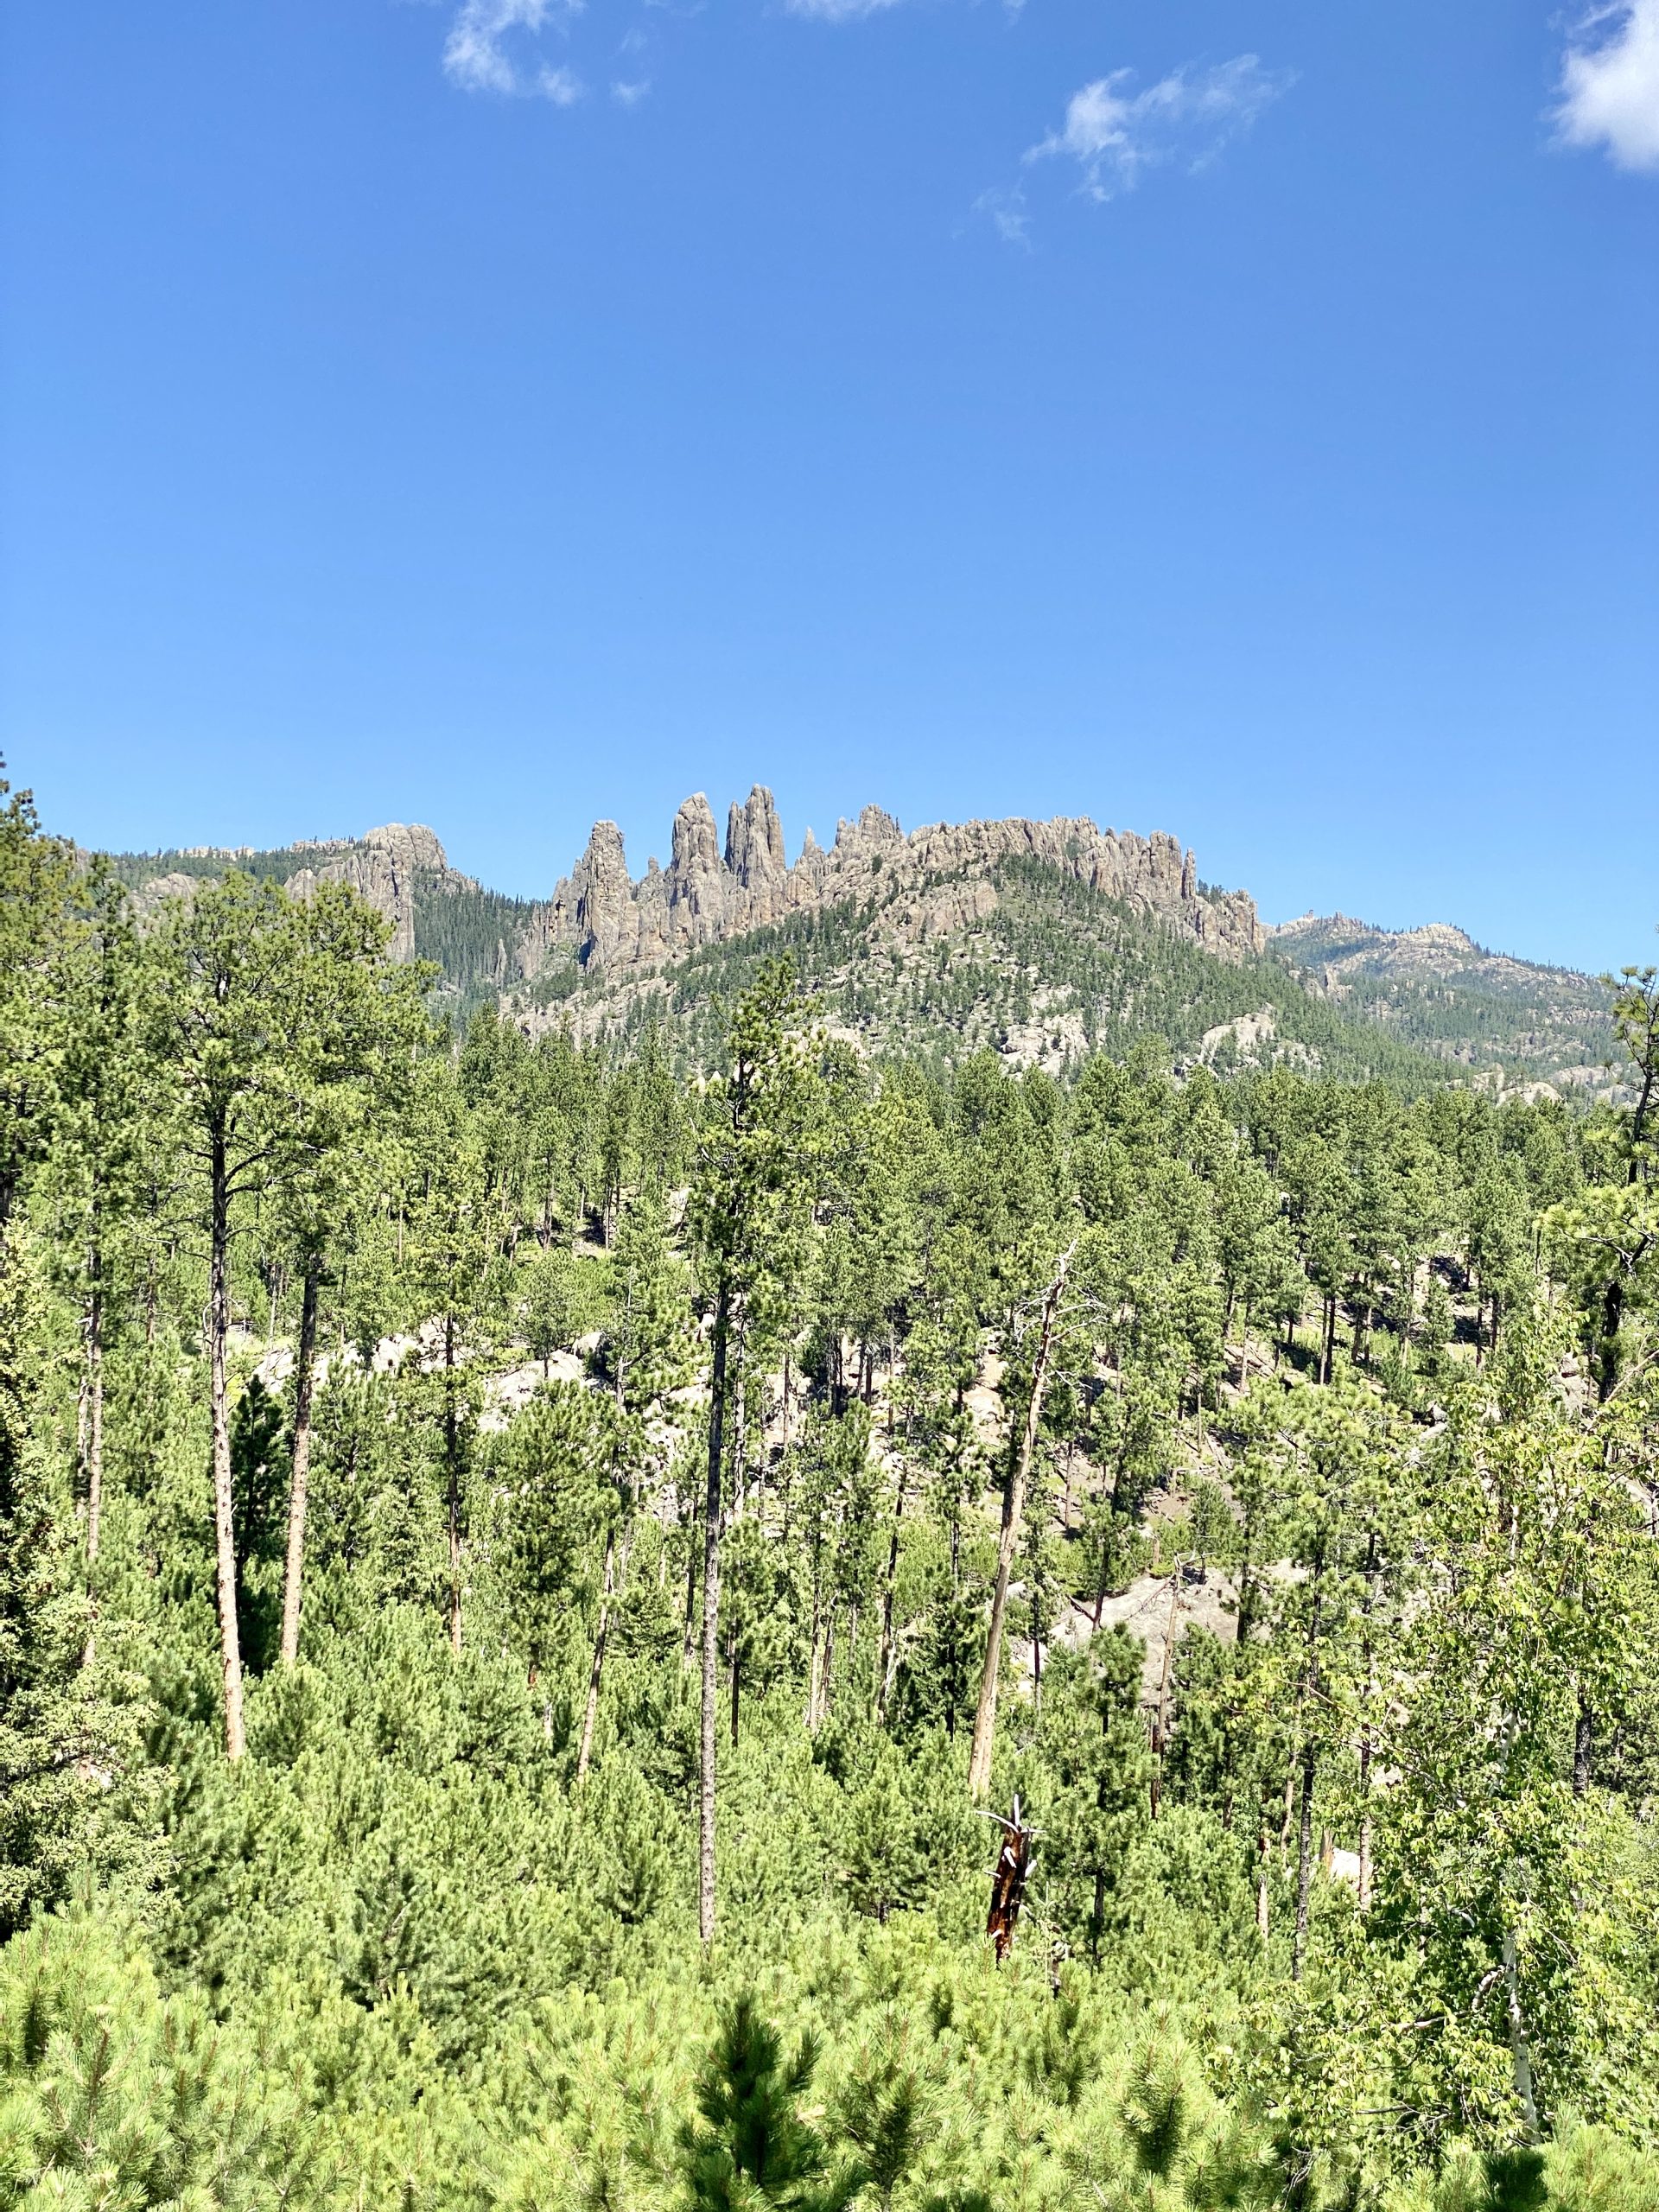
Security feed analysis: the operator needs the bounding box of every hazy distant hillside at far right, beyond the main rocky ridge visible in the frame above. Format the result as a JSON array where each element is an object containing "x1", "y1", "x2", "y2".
[{"x1": 1268, "y1": 913, "x2": 1612, "y2": 1093}]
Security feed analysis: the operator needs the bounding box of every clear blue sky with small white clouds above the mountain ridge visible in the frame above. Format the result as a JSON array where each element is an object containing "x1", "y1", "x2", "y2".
[{"x1": 0, "y1": 0, "x2": 1659, "y2": 967}]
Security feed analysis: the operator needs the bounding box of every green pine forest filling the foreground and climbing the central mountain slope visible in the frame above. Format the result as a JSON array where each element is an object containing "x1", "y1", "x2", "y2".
[{"x1": 13, "y1": 769, "x2": 1659, "y2": 2212}]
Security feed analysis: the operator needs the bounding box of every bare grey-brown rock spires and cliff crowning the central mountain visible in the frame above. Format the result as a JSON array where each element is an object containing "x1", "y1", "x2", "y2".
[{"x1": 518, "y1": 783, "x2": 1265, "y2": 976}]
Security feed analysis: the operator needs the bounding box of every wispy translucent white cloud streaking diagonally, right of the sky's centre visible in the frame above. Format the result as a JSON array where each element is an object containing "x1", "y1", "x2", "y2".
[{"x1": 1027, "y1": 53, "x2": 1292, "y2": 199}]
